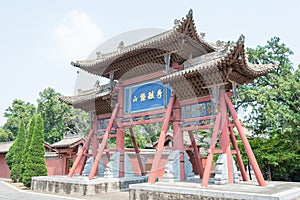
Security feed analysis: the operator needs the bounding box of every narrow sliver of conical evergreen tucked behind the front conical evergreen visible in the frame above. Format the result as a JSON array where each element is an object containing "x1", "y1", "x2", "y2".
[{"x1": 20, "y1": 114, "x2": 36, "y2": 181}]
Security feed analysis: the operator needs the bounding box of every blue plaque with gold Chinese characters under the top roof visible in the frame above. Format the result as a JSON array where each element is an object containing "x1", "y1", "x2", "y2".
[{"x1": 125, "y1": 81, "x2": 171, "y2": 113}]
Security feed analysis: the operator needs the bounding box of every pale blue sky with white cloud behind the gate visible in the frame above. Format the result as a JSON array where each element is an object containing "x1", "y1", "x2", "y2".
[{"x1": 0, "y1": 0, "x2": 300, "y2": 126}]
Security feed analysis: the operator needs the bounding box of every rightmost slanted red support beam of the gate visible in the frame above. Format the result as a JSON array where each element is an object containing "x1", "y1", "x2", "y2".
[{"x1": 224, "y1": 94, "x2": 266, "y2": 186}]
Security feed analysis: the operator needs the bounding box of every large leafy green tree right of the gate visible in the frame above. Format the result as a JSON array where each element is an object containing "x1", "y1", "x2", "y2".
[{"x1": 237, "y1": 37, "x2": 300, "y2": 181}]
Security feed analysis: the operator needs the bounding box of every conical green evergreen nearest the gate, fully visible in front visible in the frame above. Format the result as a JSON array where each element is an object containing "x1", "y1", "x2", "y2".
[{"x1": 22, "y1": 115, "x2": 47, "y2": 187}]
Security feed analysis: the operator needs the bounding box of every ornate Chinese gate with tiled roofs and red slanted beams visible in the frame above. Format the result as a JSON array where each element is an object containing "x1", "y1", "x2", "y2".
[{"x1": 61, "y1": 11, "x2": 274, "y2": 187}]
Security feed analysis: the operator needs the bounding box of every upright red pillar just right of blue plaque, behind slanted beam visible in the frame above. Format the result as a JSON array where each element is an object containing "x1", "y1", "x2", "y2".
[{"x1": 173, "y1": 98, "x2": 185, "y2": 181}]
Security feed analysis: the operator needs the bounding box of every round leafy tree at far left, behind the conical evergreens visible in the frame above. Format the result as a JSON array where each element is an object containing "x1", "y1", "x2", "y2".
[{"x1": 3, "y1": 99, "x2": 35, "y2": 141}]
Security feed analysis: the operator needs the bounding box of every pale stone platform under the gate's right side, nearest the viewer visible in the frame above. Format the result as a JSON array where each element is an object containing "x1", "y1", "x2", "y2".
[{"x1": 129, "y1": 181, "x2": 300, "y2": 200}]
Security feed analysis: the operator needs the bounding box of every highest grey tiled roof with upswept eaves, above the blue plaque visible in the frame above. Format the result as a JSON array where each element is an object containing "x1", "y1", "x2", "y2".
[{"x1": 71, "y1": 10, "x2": 215, "y2": 79}]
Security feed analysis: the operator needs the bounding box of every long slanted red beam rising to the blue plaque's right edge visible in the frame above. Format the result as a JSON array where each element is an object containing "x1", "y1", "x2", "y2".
[{"x1": 148, "y1": 96, "x2": 175, "y2": 184}]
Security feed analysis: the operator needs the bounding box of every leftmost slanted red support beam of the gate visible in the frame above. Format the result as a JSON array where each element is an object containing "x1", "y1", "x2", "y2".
[{"x1": 67, "y1": 114, "x2": 98, "y2": 178}]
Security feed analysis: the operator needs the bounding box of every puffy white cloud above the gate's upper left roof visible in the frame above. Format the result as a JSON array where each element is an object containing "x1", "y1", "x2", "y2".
[{"x1": 47, "y1": 10, "x2": 103, "y2": 62}]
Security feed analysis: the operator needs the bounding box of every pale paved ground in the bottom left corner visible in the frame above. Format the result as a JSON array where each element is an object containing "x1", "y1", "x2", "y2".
[{"x1": 0, "y1": 180, "x2": 129, "y2": 200}]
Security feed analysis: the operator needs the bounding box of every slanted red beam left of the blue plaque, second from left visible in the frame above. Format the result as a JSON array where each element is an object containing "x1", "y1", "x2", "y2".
[{"x1": 89, "y1": 103, "x2": 119, "y2": 180}]
